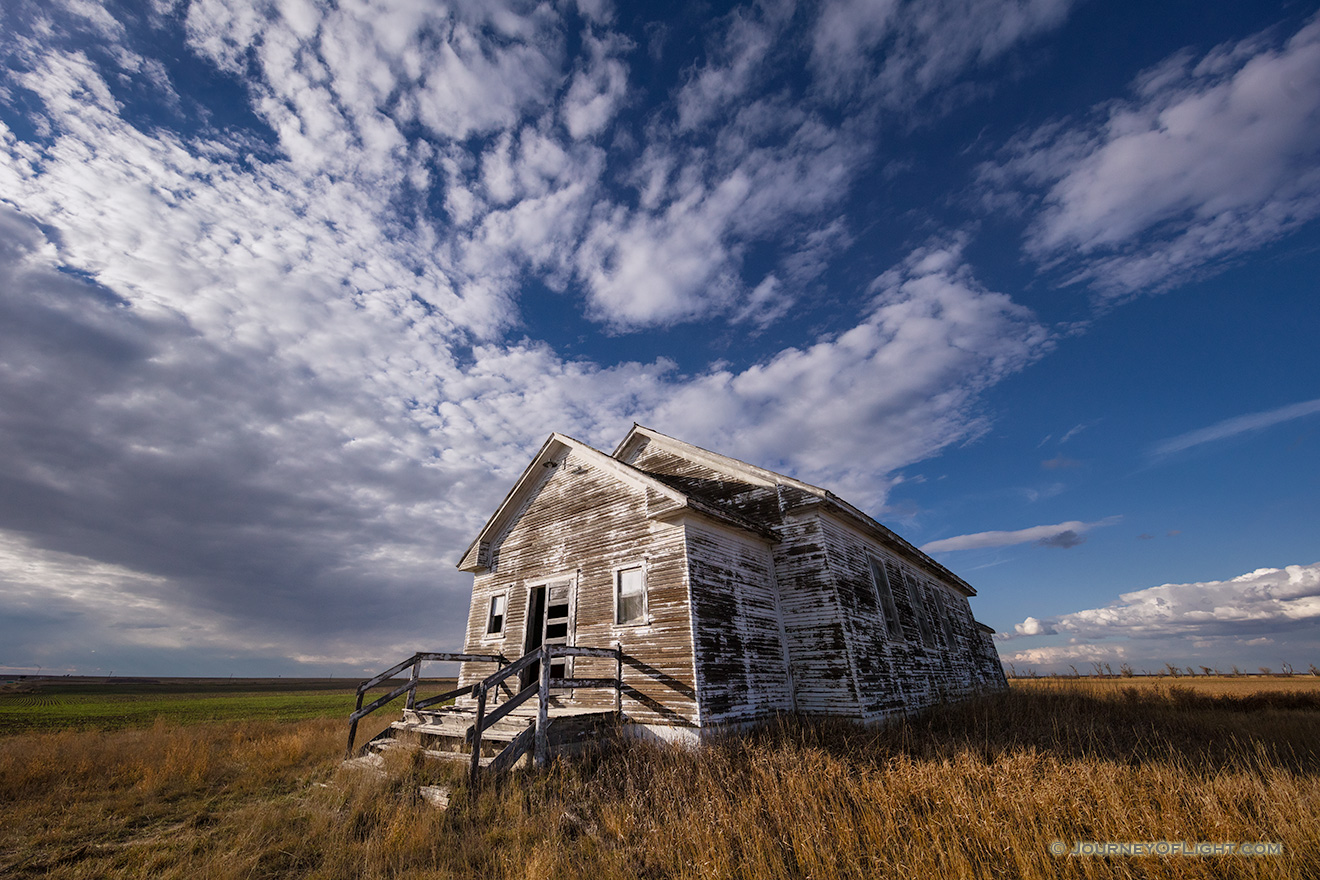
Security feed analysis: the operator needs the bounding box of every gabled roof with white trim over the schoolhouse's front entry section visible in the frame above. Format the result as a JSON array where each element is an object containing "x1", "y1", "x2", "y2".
[{"x1": 458, "y1": 433, "x2": 775, "y2": 571}]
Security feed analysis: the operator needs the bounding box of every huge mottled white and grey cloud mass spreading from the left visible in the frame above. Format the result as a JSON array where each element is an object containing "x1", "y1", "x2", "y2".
[{"x1": 0, "y1": 0, "x2": 1051, "y2": 675}]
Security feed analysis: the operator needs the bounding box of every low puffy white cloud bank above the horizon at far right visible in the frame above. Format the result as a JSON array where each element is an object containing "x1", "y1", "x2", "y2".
[{"x1": 1016, "y1": 562, "x2": 1320, "y2": 640}]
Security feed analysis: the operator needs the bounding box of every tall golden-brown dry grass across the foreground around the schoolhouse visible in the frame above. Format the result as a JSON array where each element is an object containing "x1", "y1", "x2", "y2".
[{"x1": 0, "y1": 689, "x2": 1320, "y2": 880}]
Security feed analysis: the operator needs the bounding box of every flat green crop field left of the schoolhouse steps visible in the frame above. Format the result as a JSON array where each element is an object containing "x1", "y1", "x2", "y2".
[{"x1": 0, "y1": 678, "x2": 453, "y2": 736}]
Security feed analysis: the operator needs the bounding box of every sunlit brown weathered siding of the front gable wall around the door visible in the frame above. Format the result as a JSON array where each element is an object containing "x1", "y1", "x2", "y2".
[{"x1": 461, "y1": 451, "x2": 700, "y2": 726}]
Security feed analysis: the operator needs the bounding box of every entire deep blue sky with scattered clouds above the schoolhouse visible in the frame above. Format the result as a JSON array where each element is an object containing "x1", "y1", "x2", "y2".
[{"x1": 0, "y1": 0, "x2": 1320, "y2": 674}]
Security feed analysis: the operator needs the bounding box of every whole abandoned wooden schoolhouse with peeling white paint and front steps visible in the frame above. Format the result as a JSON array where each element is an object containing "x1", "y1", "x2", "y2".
[{"x1": 345, "y1": 425, "x2": 1006, "y2": 772}]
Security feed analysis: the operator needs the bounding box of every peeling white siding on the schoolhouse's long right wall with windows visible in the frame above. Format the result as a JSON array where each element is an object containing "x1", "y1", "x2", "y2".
[{"x1": 821, "y1": 516, "x2": 1002, "y2": 720}]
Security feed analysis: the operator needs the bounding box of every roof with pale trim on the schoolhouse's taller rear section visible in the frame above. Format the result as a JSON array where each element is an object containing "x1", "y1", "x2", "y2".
[{"x1": 614, "y1": 422, "x2": 977, "y2": 596}]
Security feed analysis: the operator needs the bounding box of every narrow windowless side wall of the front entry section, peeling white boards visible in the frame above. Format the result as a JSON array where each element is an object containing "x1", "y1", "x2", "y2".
[{"x1": 686, "y1": 521, "x2": 793, "y2": 724}]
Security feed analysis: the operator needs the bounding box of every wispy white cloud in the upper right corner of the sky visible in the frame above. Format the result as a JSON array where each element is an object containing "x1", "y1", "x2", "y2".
[{"x1": 983, "y1": 18, "x2": 1320, "y2": 296}]
